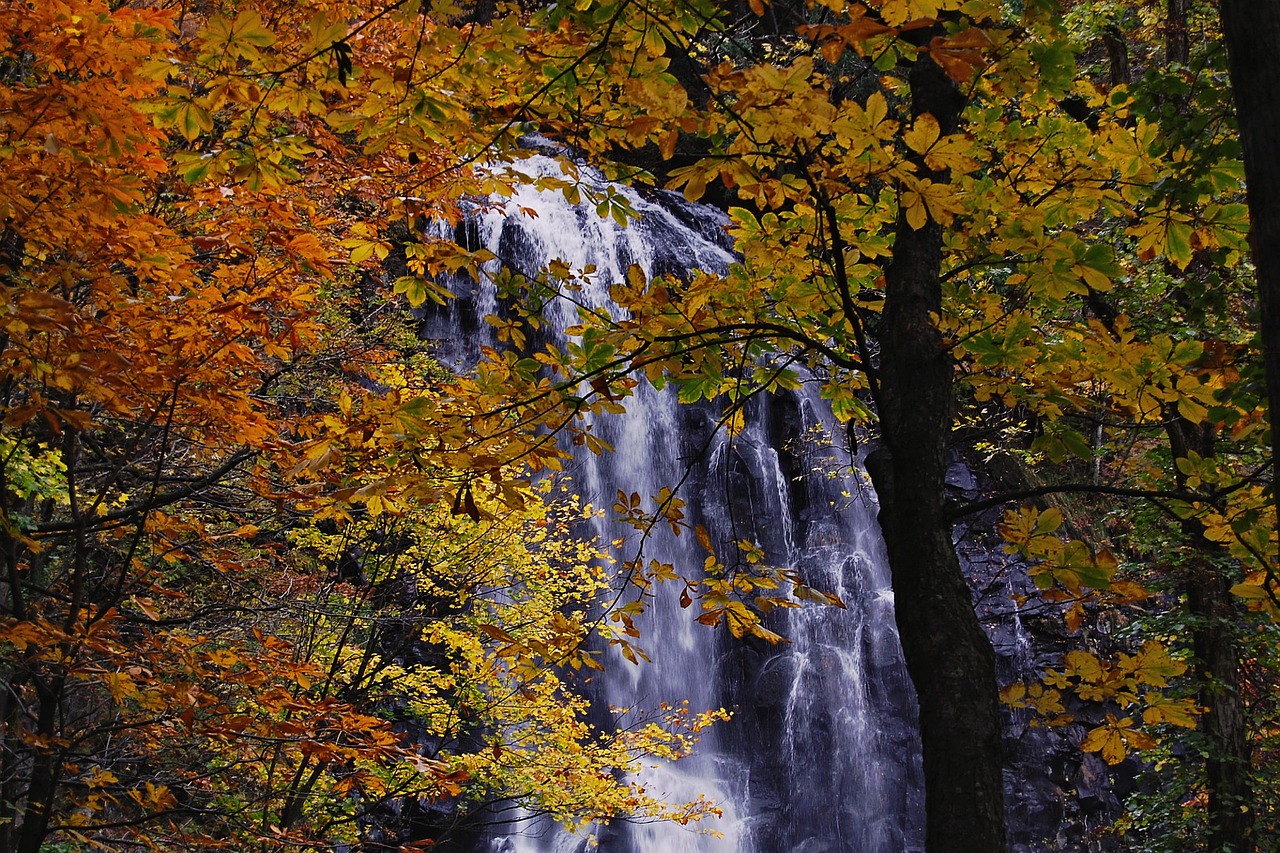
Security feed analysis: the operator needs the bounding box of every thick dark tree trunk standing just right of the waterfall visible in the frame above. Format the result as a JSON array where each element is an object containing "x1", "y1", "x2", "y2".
[{"x1": 868, "y1": 43, "x2": 1006, "y2": 853}]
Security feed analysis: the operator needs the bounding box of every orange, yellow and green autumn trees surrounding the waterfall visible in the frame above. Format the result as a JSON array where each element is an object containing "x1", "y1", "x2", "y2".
[{"x1": 0, "y1": 0, "x2": 1280, "y2": 853}]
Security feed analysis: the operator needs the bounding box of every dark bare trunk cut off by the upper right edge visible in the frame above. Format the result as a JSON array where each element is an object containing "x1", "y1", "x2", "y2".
[{"x1": 1221, "y1": 0, "x2": 1280, "y2": 558}]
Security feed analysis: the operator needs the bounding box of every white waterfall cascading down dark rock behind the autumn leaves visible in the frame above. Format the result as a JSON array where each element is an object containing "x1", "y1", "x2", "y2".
[{"x1": 424, "y1": 154, "x2": 923, "y2": 853}]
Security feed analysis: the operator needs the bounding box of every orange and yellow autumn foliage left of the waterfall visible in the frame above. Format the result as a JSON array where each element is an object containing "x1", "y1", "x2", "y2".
[{"x1": 0, "y1": 1, "x2": 732, "y2": 853}]
